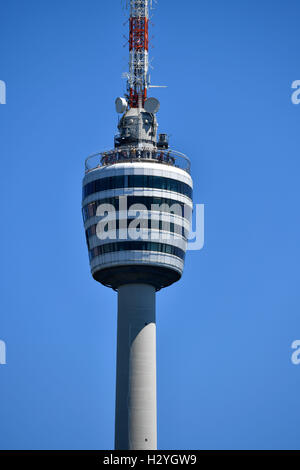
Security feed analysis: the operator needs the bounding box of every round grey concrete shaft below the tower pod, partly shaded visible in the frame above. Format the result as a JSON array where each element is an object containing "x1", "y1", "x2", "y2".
[{"x1": 115, "y1": 284, "x2": 157, "y2": 450}]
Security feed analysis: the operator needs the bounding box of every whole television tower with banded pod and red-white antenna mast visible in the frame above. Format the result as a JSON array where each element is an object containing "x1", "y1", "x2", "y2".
[{"x1": 82, "y1": 0, "x2": 193, "y2": 450}]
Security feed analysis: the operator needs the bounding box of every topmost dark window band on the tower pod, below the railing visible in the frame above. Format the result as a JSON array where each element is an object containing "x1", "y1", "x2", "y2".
[{"x1": 82, "y1": 175, "x2": 193, "y2": 199}]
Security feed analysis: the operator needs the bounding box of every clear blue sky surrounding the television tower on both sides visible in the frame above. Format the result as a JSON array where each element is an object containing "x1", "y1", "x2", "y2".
[{"x1": 0, "y1": 0, "x2": 300, "y2": 449}]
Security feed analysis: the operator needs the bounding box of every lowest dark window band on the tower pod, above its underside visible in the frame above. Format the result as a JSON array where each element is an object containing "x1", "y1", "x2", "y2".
[{"x1": 89, "y1": 241, "x2": 185, "y2": 261}]
